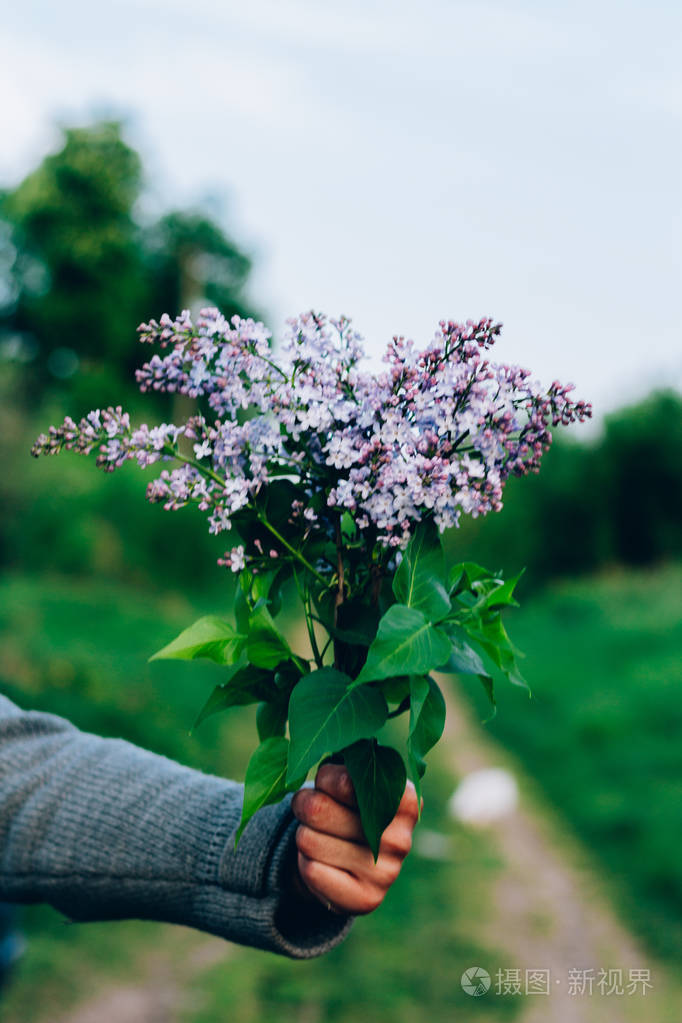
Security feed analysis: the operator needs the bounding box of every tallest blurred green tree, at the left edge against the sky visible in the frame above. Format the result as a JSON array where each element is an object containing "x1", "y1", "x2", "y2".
[{"x1": 0, "y1": 122, "x2": 145, "y2": 401}]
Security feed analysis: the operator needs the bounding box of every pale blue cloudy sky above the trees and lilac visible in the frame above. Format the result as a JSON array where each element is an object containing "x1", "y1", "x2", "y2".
[{"x1": 0, "y1": 0, "x2": 682, "y2": 427}]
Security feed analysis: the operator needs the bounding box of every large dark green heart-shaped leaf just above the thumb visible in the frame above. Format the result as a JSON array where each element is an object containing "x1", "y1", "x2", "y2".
[{"x1": 287, "y1": 668, "x2": 389, "y2": 779}]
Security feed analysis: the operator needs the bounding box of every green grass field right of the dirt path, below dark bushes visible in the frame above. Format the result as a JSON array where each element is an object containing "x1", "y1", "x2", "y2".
[{"x1": 463, "y1": 567, "x2": 682, "y2": 958}]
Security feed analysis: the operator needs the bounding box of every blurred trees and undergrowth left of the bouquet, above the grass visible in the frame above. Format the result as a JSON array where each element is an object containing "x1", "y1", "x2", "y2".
[{"x1": 0, "y1": 121, "x2": 255, "y2": 587}]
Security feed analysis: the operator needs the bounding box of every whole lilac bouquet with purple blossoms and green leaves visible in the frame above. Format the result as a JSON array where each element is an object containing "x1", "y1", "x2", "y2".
[{"x1": 33, "y1": 309, "x2": 591, "y2": 856}]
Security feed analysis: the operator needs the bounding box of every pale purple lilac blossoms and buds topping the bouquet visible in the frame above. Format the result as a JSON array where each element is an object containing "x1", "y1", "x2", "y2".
[{"x1": 33, "y1": 309, "x2": 591, "y2": 571}]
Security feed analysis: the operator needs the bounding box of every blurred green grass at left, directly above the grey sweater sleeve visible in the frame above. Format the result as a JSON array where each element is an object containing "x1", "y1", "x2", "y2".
[{"x1": 0, "y1": 576, "x2": 252, "y2": 772}]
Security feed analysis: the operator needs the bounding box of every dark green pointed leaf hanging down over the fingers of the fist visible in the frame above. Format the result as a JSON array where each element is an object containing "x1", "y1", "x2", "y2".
[{"x1": 343, "y1": 739, "x2": 406, "y2": 860}]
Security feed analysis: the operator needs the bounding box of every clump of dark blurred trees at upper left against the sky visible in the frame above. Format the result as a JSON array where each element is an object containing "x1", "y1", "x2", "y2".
[{"x1": 0, "y1": 121, "x2": 258, "y2": 412}]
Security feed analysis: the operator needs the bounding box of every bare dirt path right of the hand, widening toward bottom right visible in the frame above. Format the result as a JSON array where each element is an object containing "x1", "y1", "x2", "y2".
[{"x1": 444, "y1": 684, "x2": 682, "y2": 1023}]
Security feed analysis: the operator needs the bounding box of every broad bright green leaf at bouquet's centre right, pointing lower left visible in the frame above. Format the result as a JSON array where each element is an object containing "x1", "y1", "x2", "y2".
[{"x1": 355, "y1": 604, "x2": 451, "y2": 685}]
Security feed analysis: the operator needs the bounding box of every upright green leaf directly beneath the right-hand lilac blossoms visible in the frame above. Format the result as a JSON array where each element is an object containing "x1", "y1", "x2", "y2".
[{"x1": 393, "y1": 521, "x2": 450, "y2": 622}]
